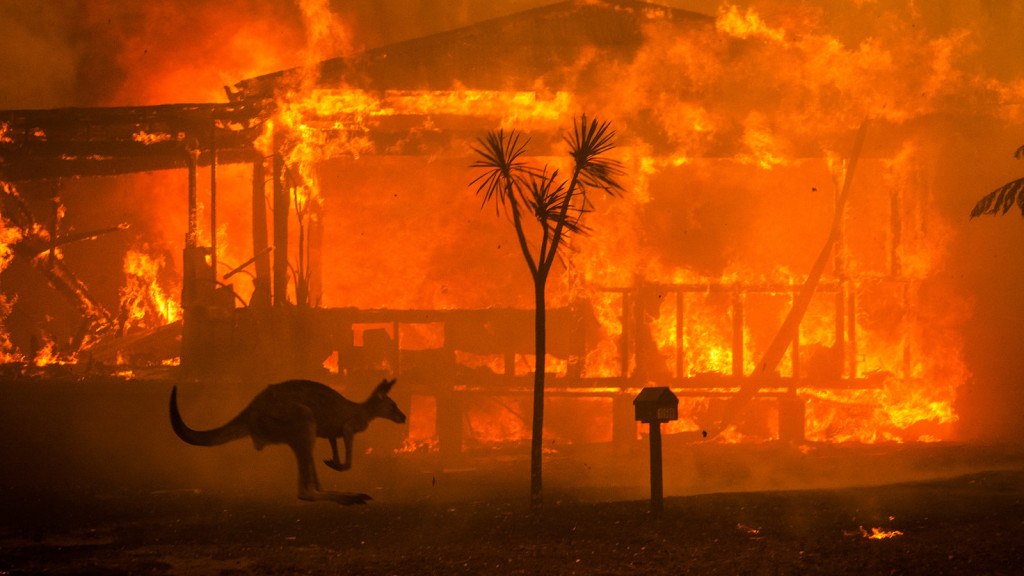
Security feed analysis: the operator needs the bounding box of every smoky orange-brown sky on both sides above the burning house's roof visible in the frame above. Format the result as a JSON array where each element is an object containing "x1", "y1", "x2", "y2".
[{"x1": 0, "y1": 0, "x2": 1024, "y2": 109}]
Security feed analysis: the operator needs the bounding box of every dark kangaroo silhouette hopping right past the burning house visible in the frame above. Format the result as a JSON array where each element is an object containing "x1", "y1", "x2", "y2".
[{"x1": 171, "y1": 379, "x2": 406, "y2": 504}]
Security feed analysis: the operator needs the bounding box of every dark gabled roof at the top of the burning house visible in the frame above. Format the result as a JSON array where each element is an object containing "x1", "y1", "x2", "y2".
[{"x1": 228, "y1": 0, "x2": 714, "y2": 99}]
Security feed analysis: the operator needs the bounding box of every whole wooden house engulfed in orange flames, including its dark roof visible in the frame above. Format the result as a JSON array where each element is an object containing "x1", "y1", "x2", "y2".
[{"x1": 0, "y1": 0, "x2": 1021, "y2": 452}]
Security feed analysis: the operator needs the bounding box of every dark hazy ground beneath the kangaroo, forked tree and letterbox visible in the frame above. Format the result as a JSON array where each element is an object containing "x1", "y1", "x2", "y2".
[{"x1": 0, "y1": 375, "x2": 1024, "y2": 575}]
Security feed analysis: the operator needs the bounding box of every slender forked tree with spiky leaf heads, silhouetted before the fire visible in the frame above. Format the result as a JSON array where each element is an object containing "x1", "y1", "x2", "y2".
[{"x1": 470, "y1": 116, "x2": 623, "y2": 508}]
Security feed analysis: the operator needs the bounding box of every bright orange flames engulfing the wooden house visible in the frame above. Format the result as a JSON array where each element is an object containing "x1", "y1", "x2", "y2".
[{"x1": 0, "y1": 0, "x2": 1024, "y2": 450}]
